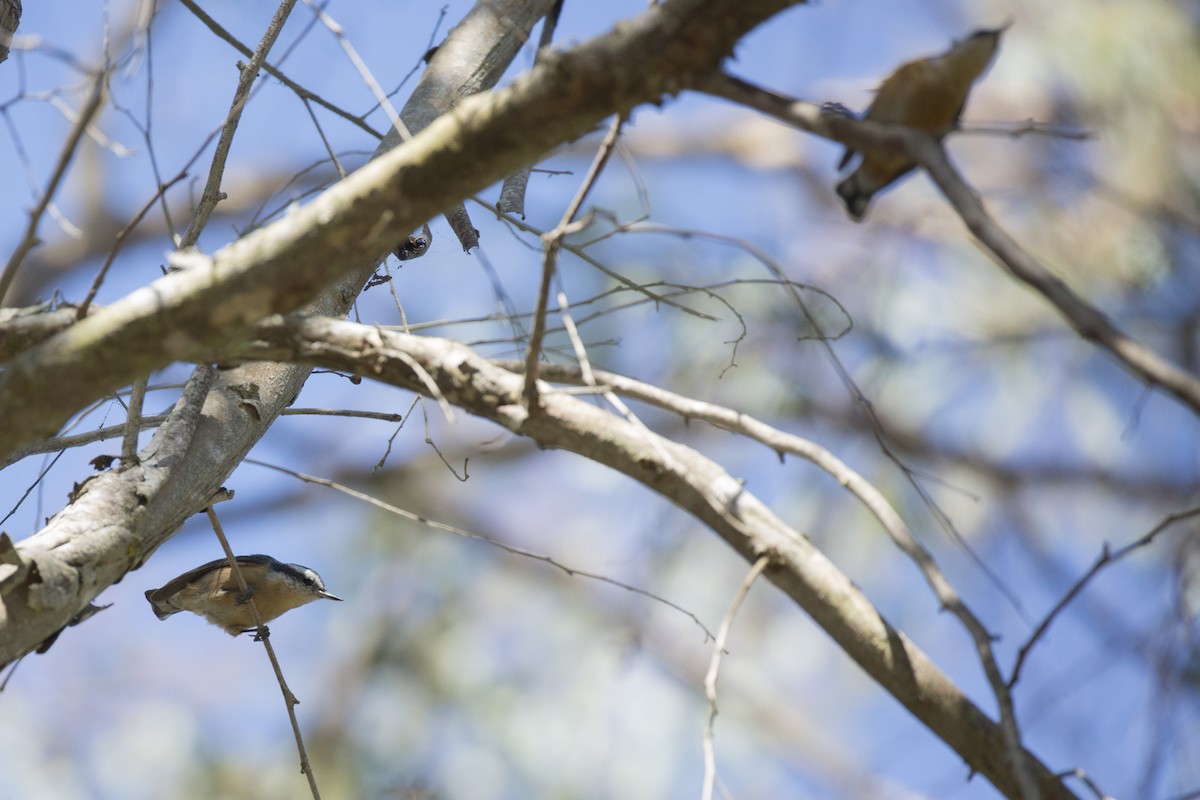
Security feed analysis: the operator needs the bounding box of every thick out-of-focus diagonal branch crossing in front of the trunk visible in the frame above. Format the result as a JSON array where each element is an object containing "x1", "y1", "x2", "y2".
[{"x1": 0, "y1": 0, "x2": 796, "y2": 457}]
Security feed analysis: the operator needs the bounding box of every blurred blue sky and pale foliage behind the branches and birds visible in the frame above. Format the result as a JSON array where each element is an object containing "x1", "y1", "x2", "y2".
[{"x1": 0, "y1": 0, "x2": 1200, "y2": 800}]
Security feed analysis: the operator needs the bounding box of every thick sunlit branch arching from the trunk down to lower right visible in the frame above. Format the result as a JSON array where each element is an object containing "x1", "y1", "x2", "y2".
[{"x1": 229, "y1": 315, "x2": 1073, "y2": 800}]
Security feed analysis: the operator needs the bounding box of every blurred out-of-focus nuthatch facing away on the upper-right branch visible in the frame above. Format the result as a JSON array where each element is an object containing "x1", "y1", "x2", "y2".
[{"x1": 838, "y1": 25, "x2": 1008, "y2": 222}]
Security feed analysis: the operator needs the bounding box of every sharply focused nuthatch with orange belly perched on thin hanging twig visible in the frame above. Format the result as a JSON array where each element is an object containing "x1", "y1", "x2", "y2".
[{"x1": 146, "y1": 555, "x2": 341, "y2": 636}]
